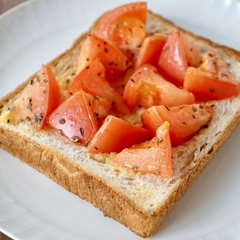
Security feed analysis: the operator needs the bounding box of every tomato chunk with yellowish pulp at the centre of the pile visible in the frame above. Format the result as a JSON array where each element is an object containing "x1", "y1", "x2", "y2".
[{"x1": 123, "y1": 64, "x2": 195, "y2": 110}]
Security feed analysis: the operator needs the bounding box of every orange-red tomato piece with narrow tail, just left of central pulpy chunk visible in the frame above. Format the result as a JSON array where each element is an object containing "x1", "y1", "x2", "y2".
[{"x1": 68, "y1": 58, "x2": 129, "y2": 114}]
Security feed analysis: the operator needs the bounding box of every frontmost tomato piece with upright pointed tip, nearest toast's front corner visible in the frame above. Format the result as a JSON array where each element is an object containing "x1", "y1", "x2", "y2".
[{"x1": 113, "y1": 122, "x2": 173, "y2": 178}]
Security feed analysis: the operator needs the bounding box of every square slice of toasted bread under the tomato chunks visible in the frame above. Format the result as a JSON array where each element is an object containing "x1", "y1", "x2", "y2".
[{"x1": 0, "y1": 3, "x2": 240, "y2": 237}]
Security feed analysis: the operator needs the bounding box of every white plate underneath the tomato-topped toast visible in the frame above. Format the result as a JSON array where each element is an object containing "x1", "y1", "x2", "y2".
[{"x1": 0, "y1": 0, "x2": 240, "y2": 240}]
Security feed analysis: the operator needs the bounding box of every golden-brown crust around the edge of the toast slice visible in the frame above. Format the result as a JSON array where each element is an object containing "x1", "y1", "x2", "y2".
[{"x1": 0, "y1": 9, "x2": 240, "y2": 237}]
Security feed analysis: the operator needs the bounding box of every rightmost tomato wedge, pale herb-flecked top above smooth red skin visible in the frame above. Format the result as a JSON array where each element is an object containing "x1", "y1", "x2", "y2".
[{"x1": 184, "y1": 49, "x2": 239, "y2": 101}]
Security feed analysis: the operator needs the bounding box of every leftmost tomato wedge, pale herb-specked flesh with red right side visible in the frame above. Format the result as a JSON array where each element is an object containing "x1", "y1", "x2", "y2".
[{"x1": 12, "y1": 65, "x2": 61, "y2": 129}]
